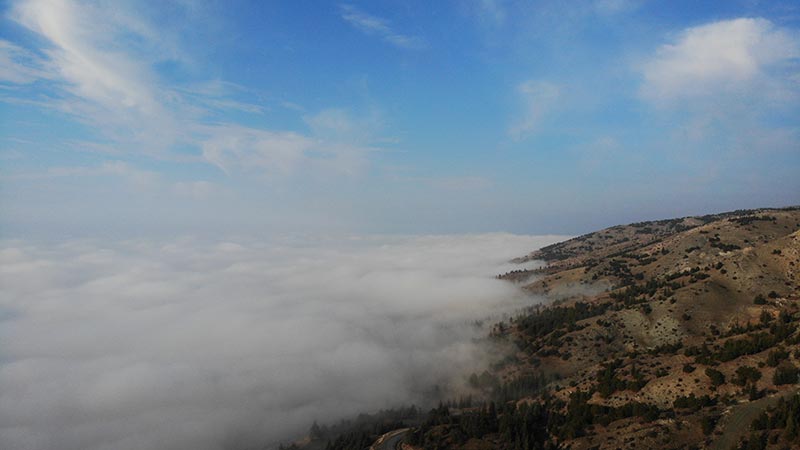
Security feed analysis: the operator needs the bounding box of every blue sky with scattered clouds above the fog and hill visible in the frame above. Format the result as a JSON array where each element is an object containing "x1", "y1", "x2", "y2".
[{"x1": 0, "y1": 0, "x2": 800, "y2": 237}]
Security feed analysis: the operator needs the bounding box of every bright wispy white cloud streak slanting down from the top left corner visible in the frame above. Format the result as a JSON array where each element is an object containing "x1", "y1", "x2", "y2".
[{"x1": 10, "y1": 0, "x2": 186, "y2": 154}]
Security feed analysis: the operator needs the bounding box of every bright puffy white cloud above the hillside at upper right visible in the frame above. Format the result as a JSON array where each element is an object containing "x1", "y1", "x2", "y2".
[{"x1": 641, "y1": 18, "x2": 800, "y2": 102}]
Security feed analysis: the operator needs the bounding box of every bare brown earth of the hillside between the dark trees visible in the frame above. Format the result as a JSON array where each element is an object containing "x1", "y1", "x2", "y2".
[{"x1": 500, "y1": 208, "x2": 800, "y2": 449}]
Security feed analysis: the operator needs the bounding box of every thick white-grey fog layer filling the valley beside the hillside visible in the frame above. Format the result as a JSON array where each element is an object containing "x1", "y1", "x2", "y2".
[{"x1": 0, "y1": 234, "x2": 557, "y2": 450}]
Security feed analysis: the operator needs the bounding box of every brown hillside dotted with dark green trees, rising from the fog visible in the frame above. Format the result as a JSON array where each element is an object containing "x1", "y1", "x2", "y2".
[{"x1": 304, "y1": 208, "x2": 800, "y2": 450}]
